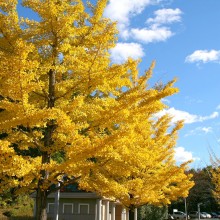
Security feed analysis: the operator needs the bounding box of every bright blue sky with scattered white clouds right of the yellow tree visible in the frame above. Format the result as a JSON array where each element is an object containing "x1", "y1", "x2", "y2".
[{"x1": 19, "y1": 0, "x2": 220, "y2": 168}]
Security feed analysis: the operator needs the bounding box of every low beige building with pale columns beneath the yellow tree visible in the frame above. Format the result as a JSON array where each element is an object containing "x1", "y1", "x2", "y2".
[{"x1": 32, "y1": 185, "x2": 137, "y2": 220}]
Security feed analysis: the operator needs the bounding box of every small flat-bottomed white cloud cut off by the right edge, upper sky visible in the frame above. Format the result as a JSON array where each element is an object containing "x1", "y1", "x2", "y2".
[{"x1": 185, "y1": 50, "x2": 220, "y2": 63}]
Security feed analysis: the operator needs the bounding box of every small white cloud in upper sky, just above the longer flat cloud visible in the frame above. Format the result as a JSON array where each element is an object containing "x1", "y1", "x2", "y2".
[{"x1": 147, "y1": 8, "x2": 182, "y2": 26}]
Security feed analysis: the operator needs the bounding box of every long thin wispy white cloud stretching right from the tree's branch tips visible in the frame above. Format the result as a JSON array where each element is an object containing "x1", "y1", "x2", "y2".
[{"x1": 156, "y1": 108, "x2": 219, "y2": 124}]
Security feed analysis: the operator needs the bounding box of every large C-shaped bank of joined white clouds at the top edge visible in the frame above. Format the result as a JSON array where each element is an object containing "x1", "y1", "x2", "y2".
[{"x1": 104, "y1": 0, "x2": 182, "y2": 43}]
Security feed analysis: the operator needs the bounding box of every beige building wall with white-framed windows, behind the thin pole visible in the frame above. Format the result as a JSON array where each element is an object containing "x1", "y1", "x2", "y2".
[{"x1": 47, "y1": 198, "x2": 96, "y2": 220}]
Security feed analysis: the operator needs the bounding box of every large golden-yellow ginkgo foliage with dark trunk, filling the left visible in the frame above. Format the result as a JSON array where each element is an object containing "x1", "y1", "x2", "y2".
[{"x1": 0, "y1": 0, "x2": 193, "y2": 220}]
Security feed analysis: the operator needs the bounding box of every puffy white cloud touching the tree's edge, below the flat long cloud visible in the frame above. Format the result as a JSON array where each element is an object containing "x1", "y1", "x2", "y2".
[{"x1": 110, "y1": 43, "x2": 144, "y2": 63}]
